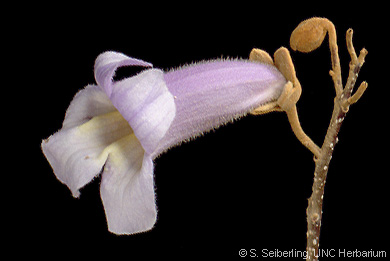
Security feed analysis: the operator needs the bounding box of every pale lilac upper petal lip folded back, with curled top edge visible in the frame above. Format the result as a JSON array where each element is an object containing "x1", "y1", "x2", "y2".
[{"x1": 95, "y1": 52, "x2": 176, "y2": 154}]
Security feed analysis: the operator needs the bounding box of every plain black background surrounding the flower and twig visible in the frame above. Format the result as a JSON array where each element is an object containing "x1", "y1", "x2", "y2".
[{"x1": 10, "y1": 2, "x2": 390, "y2": 260}]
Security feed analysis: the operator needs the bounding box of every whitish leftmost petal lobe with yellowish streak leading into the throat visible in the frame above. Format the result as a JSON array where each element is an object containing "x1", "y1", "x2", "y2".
[{"x1": 41, "y1": 94, "x2": 133, "y2": 197}]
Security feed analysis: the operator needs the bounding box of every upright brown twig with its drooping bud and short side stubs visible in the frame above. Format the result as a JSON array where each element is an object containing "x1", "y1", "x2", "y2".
[{"x1": 290, "y1": 18, "x2": 367, "y2": 260}]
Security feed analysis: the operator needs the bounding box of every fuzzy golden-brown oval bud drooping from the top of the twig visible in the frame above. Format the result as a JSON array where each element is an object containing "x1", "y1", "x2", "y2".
[{"x1": 290, "y1": 17, "x2": 328, "y2": 53}]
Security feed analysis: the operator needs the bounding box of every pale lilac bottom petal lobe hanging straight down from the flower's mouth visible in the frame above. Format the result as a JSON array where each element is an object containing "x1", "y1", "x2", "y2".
[{"x1": 100, "y1": 135, "x2": 157, "y2": 234}]
